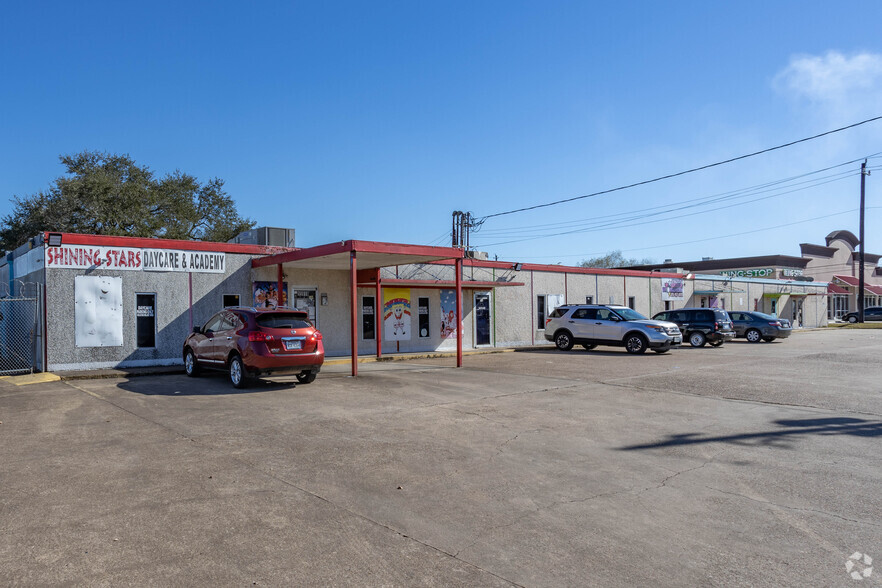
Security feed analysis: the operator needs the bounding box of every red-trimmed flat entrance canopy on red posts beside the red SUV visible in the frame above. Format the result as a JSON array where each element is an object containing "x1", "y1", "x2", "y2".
[{"x1": 251, "y1": 240, "x2": 464, "y2": 376}]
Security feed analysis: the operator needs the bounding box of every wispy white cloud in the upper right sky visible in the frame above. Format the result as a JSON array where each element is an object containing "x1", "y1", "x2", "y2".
[{"x1": 774, "y1": 51, "x2": 882, "y2": 103}]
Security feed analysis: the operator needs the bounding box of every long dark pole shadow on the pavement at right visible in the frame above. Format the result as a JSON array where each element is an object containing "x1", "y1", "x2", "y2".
[{"x1": 620, "y1": 417, "x2": 882, "y2": 451}]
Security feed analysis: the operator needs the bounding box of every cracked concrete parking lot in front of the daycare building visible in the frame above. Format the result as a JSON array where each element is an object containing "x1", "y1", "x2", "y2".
[{"x1": 0, "y1": 329, "x2": 882, "y2": 586}]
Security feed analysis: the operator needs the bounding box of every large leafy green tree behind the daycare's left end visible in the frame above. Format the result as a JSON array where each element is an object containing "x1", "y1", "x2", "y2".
[{"x1": 0, "y1": 151, "x2": 254, "y2": 251}]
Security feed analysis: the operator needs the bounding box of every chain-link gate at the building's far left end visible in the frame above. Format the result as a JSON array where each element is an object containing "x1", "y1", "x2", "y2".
[{"x1": 0, "y1": 284, "x2": 40, "y2": 376}]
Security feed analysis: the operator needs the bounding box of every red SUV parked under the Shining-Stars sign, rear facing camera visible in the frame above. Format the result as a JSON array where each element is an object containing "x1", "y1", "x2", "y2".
[{"x1": 183, "y1": 307, "x2": 325, "y2": 388}]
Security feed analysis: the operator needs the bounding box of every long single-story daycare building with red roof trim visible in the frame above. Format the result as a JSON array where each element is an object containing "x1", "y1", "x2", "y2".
[{"x1": 0, "y1": 231, "x2": 827, "y2": 373}]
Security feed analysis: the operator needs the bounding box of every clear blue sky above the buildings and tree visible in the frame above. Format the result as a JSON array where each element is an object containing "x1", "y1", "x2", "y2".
[{"x1": 0, "y1": 1, "x2": 882, "y2": 264}]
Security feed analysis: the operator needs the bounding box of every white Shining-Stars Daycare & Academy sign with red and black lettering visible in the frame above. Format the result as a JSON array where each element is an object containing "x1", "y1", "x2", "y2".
[{"x1": 46, "y1": 245, "x2": 226, "y2": 274}]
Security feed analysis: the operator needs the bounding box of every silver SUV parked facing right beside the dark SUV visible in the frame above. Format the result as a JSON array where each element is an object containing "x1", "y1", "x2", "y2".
[{"x1": 545, "y1": 304, "x2": 683, "y2": 353}]
